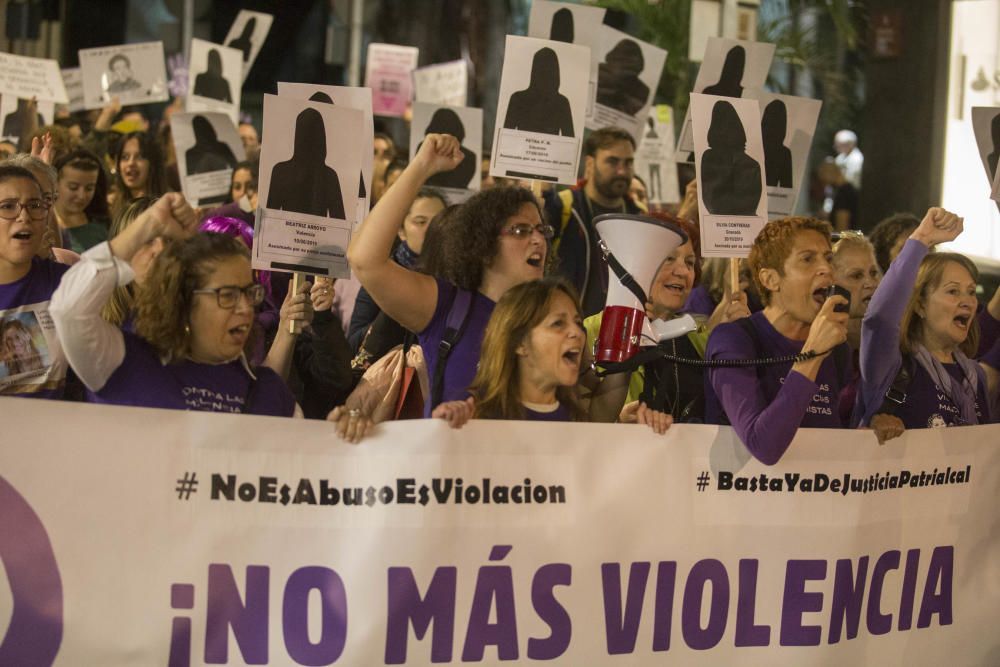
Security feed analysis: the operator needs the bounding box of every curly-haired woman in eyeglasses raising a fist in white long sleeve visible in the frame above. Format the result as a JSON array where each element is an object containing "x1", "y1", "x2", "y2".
[{"x1": 51, "y1": 193, "x2": 300, "y2": 417}]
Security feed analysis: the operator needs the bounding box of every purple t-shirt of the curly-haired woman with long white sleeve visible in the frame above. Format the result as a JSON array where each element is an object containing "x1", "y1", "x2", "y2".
[{"x1": 88, "y1": 332, "x2": 295, "y2": 417}]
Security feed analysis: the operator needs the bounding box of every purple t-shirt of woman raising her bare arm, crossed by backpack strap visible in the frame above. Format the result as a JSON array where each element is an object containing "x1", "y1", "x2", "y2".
[{"x1": 417, "y1": 278, "x2": 496, "y2": 417}]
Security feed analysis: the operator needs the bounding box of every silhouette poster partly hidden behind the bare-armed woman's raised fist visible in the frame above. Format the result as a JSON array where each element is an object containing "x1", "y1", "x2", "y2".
[{"x1": 410, "y1": 102, "x2": 483, "y2": 204}]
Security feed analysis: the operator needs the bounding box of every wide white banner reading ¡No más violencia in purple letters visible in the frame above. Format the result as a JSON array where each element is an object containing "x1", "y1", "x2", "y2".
[{"x1": 0, "y1": 399, "x2": 1000, "y2": 667}]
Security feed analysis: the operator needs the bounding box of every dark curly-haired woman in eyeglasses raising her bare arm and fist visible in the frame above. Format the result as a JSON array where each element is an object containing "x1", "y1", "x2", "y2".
[{"x1": 347, "y1": 134, "x2": 553, "y2": 419}]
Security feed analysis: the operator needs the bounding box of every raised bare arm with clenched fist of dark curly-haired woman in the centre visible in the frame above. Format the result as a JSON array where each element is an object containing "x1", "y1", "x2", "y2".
[{"x1": 347, "y1": 134, "x2": 462, "y2": 332}]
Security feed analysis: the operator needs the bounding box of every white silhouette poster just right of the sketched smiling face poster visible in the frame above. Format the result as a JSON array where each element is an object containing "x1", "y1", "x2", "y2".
[{"x1": 185, "y1": 39, "x2": 243, "y2": 125}]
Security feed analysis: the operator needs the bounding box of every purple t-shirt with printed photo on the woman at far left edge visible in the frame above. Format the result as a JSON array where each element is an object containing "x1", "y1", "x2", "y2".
[{"x1": 0, "y1": 258, "x2": 69, "y2": 398}]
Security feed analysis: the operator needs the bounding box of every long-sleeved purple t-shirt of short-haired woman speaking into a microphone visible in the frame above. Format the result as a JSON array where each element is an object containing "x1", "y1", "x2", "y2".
[{"x1": 705, "y1": 311, "x2": 850, "y2": 465}]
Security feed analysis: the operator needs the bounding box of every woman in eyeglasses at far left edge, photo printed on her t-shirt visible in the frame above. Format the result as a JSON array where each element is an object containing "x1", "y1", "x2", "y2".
[{"x1": 0, "y1": 163, "x2": 68, "y2": 398}]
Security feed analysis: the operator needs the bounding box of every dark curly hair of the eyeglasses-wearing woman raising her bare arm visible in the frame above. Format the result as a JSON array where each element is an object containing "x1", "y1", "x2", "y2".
[{"x1": 441, "y1": 187, "x2": 551, "y2": 291}]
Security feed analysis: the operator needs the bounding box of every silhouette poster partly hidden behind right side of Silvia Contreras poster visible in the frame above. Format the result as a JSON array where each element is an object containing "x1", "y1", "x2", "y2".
[{"x1": 748, "y1": 91, "x2": 823, "y2": 217}]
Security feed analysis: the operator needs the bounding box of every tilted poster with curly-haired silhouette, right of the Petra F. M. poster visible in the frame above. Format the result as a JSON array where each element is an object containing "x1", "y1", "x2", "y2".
[{"x1": 587, "y1": 25, "x2": 667, "y2": 144}]
